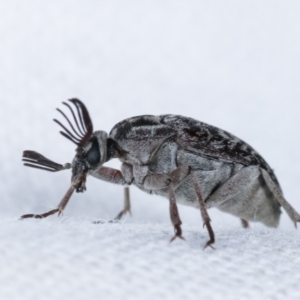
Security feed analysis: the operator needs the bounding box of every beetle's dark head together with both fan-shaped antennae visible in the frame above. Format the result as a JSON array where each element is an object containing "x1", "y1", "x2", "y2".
[{"x1": 23, "y1": 99, "x2": 107, "y2": 192}]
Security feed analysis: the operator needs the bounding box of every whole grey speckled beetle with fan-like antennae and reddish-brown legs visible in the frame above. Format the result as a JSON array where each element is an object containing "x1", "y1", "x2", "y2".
[{"x1": 21, "y1": 98, "x2": 300, "y2": 248}]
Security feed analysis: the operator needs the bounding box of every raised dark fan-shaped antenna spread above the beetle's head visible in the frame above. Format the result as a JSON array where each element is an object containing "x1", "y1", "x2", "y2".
[{"x1": 53, "y1": 98, "x2": 93, "y2": 147}]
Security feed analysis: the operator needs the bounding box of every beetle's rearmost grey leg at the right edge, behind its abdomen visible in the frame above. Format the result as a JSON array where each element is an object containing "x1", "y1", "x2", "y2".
[{"x1": 260, "y1": 169, "x2": 300, "y2": 228}]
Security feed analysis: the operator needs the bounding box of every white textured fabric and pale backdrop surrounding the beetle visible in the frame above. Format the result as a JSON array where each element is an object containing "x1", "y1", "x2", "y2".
[{"x1": 0, "y1": 1, "x2": 300, "y2": 299}]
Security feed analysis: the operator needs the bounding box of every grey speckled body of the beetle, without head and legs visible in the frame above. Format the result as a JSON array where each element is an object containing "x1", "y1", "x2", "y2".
[{"x1": 109, "y1": 115, "x2": 281, "y2": 227}]
